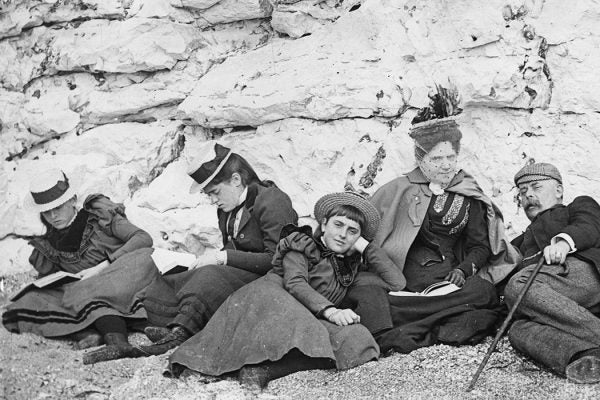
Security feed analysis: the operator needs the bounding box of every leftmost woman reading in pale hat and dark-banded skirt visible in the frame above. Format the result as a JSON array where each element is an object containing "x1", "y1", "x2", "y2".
[{"x1": 2, "y1": 169, "x2": 155, "y2": 348}]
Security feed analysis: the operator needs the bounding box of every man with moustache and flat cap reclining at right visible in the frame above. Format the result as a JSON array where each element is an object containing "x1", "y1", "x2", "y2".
[{"x1": 505, "y1": 163, "x2": 600, "y2": 383}]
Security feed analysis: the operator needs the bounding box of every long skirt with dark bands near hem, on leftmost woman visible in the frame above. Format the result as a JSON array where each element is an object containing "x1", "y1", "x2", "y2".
[{"x1": 2, "y1": 248, "x2": 159, "y2": 337}]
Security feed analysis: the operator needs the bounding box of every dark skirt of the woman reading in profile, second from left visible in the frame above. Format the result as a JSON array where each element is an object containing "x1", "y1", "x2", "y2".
[{"x1": 143, "y1": 265, "x2": 260, "y2": 333}]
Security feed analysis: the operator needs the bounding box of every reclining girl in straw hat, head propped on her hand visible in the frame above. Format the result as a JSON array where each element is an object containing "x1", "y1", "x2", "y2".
[{"x1": 170, "y1": 193, "x2": 403, "y2": 387}]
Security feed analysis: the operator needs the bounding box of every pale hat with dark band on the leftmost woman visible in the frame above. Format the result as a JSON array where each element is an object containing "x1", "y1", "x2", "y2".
[{"x1": 29, "y1": 168, "x2": 75, "y2": 213}]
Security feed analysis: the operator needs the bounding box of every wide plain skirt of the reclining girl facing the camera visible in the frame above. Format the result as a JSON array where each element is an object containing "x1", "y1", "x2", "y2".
[{"x1": 169, "y1": 274, "x2": 379, "y2": 376}]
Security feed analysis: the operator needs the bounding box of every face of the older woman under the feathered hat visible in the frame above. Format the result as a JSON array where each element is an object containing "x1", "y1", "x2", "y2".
[{"x1": 419, "y1": 142, "x2": 458, "y2": 186}]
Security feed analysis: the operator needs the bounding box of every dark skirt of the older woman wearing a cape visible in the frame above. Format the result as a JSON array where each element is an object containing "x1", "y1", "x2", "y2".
[{"x1": 377, "y1": 276, "x2": 503, "y2": 353}]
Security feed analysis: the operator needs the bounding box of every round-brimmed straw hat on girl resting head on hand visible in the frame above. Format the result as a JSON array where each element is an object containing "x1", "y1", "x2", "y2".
[{"x1": 315, "y1": 192, "x2": 381, "y2": 241}]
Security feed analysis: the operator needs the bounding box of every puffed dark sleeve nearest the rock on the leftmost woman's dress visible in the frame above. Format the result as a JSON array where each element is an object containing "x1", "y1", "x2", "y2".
[{"x1": 84, "y1": 194, "x2": 152, "y2": 262}]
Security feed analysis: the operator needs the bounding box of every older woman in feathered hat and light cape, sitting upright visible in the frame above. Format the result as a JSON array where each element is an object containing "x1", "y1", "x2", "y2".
[{"x1": 364, "y1": 88, "x2": 519, "y2": 353}]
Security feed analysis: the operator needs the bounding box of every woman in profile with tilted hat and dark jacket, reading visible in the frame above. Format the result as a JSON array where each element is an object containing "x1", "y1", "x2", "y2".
[{"x1": 84, "y1": 142, "x2": 298, "y2": 364}]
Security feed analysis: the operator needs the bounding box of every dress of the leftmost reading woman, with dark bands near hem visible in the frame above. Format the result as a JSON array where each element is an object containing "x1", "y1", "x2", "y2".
[{"x1": 2, "y1": 194, "x2": 157, "y2": 337}]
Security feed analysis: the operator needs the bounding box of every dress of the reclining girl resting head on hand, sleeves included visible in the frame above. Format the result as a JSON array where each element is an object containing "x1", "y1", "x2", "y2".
[{"x1": 170, "y1": 228, "x2": 403, "y2": 376}]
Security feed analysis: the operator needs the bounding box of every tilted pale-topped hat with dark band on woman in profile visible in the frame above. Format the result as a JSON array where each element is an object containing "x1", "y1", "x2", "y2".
[{"x1": 188, "y1": 142, "x2": 233, "y2": 193}]
